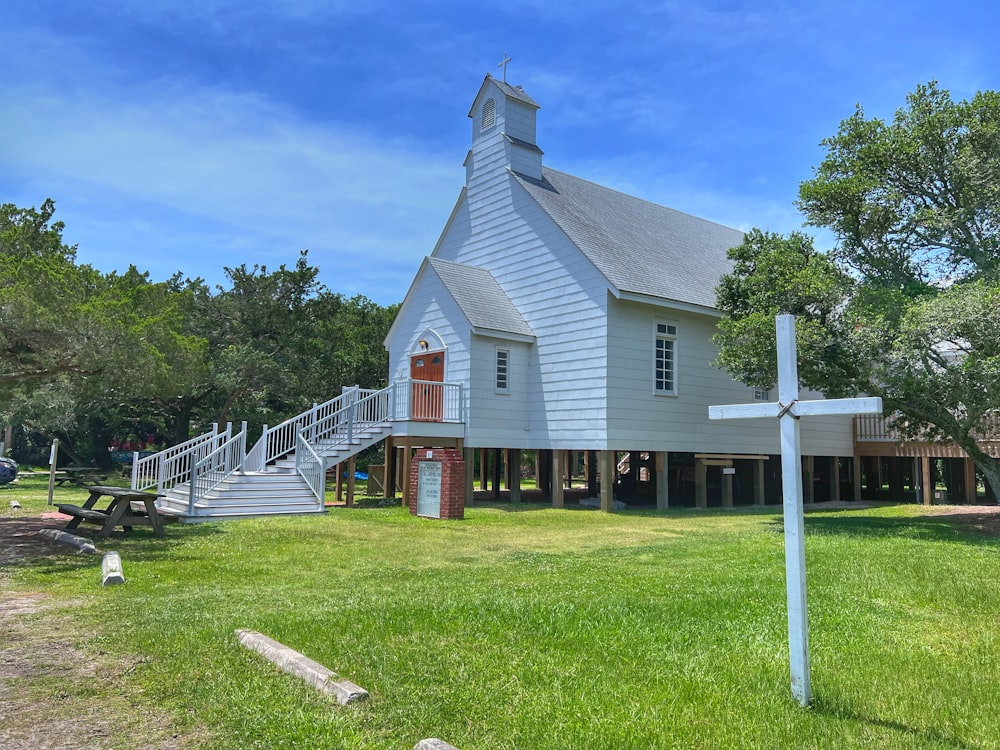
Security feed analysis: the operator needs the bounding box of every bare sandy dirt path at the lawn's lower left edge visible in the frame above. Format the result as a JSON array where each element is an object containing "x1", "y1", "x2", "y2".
[{"x1": 0, "y1": 516, "x2": 199, "y2": 750}]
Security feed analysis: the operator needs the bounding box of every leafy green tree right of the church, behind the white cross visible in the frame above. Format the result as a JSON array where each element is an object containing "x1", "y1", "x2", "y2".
[{"x1": 716, "y1": 83, "x2": 1000, "y2": 494}]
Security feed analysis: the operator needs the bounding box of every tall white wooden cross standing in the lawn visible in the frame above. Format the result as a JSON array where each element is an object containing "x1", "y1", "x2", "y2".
[{"x1": 708, "y1": 315, "x2": 882, "y2": 706}]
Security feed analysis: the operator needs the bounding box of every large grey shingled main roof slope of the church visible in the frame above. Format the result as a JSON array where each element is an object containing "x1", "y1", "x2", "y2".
[{"x1": 514, "y1": 167, "x2": 743, "y2": 308}]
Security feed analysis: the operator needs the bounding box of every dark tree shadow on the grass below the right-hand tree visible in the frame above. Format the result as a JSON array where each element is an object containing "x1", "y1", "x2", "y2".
[{"x1": 770, "y1": 509, "x2": 1000, "y2": 546}]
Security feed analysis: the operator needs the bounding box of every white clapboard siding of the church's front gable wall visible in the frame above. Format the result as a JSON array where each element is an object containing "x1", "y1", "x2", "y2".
[{"x1": 435, "y1": 169, "x2": 608, "y2": 448}]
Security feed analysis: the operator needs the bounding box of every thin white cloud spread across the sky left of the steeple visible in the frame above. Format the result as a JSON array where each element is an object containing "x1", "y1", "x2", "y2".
[{"x1": 0, "y1": 27, "x2": 462, "y2": 302}]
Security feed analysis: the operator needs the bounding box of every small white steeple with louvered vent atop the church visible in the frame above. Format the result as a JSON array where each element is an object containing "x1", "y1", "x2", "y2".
[{"x1": 466, "y1": 73, "x2": 542, "y2": 182}]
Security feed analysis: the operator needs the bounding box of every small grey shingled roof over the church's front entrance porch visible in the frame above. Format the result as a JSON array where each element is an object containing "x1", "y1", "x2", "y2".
[{"x1": 426, "y1": 258, "x2": 535, "y2": 341}]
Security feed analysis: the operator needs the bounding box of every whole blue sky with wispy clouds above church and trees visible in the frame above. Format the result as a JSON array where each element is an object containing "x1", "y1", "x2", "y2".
[{"x1": 0, "y1": 0, "x2": 1000, "y2": 304}]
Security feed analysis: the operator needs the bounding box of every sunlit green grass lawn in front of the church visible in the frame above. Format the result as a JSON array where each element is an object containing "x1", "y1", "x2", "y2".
[{"x1": 0, "y1": 479, "x2": 1000, "y2": 750}]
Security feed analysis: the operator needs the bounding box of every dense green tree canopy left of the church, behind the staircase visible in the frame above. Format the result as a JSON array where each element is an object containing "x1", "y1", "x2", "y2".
[{"x1": 0, "y1": 200, "x2": 397, "y2": 460}]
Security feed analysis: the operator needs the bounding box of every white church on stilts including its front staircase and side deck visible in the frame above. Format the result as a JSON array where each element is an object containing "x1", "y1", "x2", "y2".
[{"x1": 148, "y1": 75, "x2": 1000, "y2": 522}]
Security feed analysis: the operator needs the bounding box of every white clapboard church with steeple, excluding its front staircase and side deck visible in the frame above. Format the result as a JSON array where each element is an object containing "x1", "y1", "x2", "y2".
[{"x1": 385, "y1": 75, "x2": 854, "y2": 508}]
